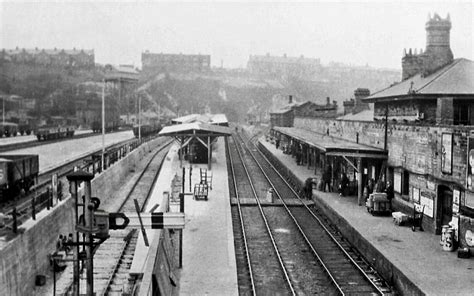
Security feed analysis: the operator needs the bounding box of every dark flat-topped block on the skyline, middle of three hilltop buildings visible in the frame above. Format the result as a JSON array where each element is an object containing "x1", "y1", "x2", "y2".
[{"x1": 142, "y1": 51, "x2": 211, "y2": 73}]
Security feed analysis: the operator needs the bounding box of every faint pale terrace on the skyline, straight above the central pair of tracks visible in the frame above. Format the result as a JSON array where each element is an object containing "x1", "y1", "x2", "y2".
[{"x1": 247, "y1": 53, "x2": 321, "y2": 79}]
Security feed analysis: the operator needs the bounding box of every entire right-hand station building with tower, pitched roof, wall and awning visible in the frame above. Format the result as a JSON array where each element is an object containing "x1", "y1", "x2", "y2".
[{"x1": 271, "y1": 15, "x2": 474, "y2": 247}]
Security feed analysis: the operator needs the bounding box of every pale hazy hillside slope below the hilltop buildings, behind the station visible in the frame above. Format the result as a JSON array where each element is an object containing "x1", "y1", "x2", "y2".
[{"x1": 137, "y1": 68, "x2": 400, "y2": 121}]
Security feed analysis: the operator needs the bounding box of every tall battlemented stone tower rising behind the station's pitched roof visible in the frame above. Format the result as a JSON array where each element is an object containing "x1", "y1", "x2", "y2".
[{"x1": 402, "y1": 13, "x2": 453, "y2": 80}]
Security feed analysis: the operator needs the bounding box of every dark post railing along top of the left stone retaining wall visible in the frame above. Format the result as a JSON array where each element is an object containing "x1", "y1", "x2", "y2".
[{"x1": 0, "y1": 137, "x2": 159, "y2": 234}]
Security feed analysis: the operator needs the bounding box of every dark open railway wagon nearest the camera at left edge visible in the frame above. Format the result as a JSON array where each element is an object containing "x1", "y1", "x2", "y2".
[{"x1": 0, "y1": 154, "x2": 39, "y2": 202}]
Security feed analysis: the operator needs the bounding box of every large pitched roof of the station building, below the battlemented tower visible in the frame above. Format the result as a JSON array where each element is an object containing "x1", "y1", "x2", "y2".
[{"x1": 362, "y1": 58, "x2": 474, "y2": 103}]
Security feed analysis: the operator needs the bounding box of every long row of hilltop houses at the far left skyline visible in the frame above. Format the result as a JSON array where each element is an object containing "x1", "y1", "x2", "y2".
[{"x1": 0, "y1": 47, "x2": 95, "y2": 68}]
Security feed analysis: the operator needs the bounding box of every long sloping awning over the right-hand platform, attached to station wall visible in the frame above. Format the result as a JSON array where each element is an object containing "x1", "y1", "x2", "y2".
[{"x1": 273, "y1": 126, "x2": 388, "y2": 159}]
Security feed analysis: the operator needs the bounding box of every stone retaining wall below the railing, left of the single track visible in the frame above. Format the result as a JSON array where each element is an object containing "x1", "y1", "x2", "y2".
[{"x1": 0, "y1": 138, "x2": 166, "y2": 295}]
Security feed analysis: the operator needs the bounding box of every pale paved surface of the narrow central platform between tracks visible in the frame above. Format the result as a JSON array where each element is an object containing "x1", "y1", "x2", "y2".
[{"x1": 179, "y1": 138, "x2": 238, "y2": 295}]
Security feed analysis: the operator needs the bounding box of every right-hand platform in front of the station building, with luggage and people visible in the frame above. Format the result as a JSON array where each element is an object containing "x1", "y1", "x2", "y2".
[{"x1": 259, "y1": 138, "x2": 474, "y2": 295}]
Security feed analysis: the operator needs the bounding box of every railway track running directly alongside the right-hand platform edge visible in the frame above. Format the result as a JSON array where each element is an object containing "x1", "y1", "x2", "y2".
[{"x1": 229, "y1": 130, "x2": 392, "y2": 295}]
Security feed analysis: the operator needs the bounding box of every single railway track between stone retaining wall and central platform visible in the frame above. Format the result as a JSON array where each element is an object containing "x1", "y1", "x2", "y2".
[{"x1": 59, "y1": 141, "x2": 172, "y2": 295}]
